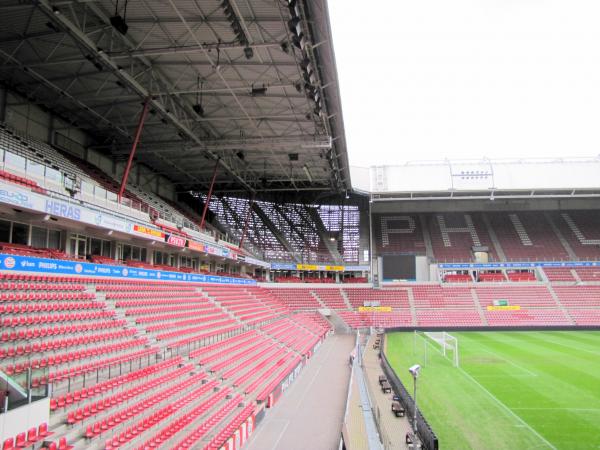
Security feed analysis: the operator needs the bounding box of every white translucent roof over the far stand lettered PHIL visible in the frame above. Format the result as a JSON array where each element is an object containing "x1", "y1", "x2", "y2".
[{"x1": 352, "y1": 157, "x2": 600, "y2": 201}]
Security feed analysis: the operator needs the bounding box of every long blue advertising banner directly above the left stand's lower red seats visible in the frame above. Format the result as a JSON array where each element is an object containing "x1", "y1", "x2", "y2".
[{"x1": 0, "y1": 254, "x2": 256, "y2": 285}]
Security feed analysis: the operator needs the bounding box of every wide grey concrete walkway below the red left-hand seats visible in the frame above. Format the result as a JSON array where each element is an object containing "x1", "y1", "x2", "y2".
[{"x1": 244, "y1": 334, "x2": 354, "y2": 450}]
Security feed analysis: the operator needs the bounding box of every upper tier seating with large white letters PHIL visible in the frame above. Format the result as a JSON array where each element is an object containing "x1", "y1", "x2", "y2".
[{"x1": 373, "y1": 210, "x2": 600, "y2": 262}]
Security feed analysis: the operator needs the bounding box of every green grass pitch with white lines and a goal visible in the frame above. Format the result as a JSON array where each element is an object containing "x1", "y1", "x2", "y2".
[{"x1": 386, "y1": 331, "x2": 600, "y2": 450}]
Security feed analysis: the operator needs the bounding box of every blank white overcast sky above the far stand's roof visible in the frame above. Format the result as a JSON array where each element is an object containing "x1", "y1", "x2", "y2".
[{"x1": 329, "y1": 0, "x2": 600, "y2": 166}]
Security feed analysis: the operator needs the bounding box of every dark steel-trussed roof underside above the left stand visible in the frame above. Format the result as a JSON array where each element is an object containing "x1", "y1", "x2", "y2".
[{"x1": 0, "y1": 0, "x2": 350, "y2": 196}]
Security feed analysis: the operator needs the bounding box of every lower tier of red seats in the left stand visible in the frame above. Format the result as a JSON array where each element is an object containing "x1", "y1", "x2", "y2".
[{"x1": 0, "y1": 275, "x2": 330, "y2": 448}]
